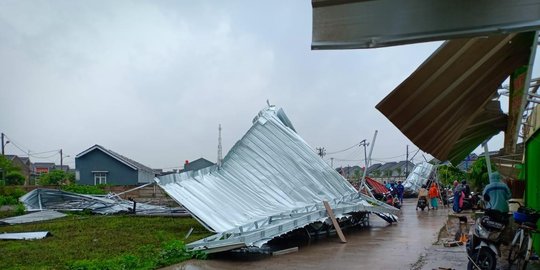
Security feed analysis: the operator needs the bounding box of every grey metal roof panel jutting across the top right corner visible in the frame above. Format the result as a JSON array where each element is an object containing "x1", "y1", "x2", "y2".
[{"x1": 311, "y1": 0, "x2": 540, "y2": 49}]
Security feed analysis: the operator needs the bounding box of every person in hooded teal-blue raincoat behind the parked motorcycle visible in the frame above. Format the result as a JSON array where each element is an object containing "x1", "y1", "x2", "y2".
[{"x1": 482, "y1": 172, "x2": 512, "y2": 213}]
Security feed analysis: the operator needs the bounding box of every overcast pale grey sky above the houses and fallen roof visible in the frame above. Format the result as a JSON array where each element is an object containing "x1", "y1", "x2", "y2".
[{"x1": 0, "y1": 0, "x2": 516, "y2": 168}]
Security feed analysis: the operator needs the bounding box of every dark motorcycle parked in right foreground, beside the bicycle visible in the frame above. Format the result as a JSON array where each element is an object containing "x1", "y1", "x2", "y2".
[{"x1": 467, "y1": 195, "x2": 508, "y2": 270}]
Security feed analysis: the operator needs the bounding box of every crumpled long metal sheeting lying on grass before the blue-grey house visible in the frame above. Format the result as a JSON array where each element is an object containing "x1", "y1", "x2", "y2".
[{"x1": 19, "y1": 188, "x2": 189, "y2": 216}]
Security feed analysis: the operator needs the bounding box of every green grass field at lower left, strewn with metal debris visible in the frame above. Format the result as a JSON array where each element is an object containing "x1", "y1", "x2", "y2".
[{"x1": 0, "y1": 215, "x2": 210, "y2": 269}]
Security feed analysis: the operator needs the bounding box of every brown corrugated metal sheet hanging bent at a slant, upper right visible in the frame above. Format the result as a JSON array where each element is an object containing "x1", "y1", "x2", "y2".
[{"x1": 376, "y1": 32, "x2": 535, "y2": 164}]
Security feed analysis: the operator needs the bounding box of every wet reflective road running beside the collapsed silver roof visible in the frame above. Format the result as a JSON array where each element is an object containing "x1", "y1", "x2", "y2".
[{"x1": 166, "y1": 199, "x2": 448, "y2": 270}]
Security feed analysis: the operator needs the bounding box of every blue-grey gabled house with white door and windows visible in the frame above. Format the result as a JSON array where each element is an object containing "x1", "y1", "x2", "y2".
[{"x1": 75, "y1": 144, "x2": 155, "y2": 185}]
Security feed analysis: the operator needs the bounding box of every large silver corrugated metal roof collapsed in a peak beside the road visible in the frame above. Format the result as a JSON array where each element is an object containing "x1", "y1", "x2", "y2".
[{"x1": 156, "y1": 106, "x2": 398, "y2": 252}]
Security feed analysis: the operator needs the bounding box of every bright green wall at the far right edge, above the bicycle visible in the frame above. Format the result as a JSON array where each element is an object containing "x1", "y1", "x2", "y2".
[{"x1": 525, "y1": 130, "x2": 540, "y2": 253}]
